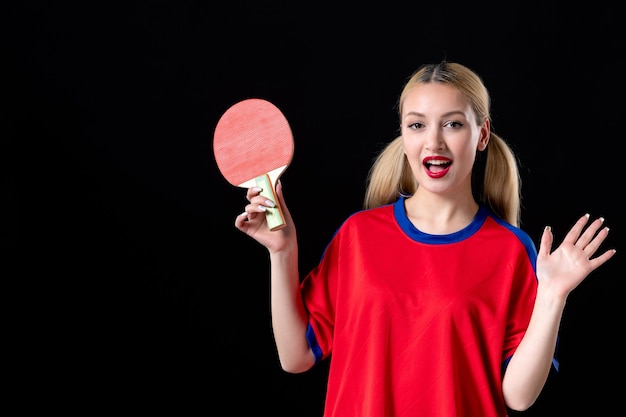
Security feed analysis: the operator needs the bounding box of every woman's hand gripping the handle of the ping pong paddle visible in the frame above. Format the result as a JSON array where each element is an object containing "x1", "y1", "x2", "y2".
[{"x1": 235, "y1": 181, "x2": 296, "y2": 252}]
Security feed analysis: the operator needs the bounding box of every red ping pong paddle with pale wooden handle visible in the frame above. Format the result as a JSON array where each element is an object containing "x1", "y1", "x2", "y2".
[{"x1": 213, "y1": 98, "x2": 294, "y2": 230}]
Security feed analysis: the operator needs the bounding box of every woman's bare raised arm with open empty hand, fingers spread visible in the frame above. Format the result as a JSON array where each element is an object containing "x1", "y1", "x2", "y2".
[{"x1": 502, "y1": 214, "x2": 615, "y2": 411}]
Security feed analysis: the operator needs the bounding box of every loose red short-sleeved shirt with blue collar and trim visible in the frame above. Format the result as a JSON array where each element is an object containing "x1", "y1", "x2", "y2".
[{"x1": 301, "y1": 198, "x2": 556, "y2": 417}]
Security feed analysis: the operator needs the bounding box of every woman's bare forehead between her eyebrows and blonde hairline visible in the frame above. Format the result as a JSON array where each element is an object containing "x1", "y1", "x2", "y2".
[{"x1": 402, "y1": 83, "x2": 471, "y2": 115}]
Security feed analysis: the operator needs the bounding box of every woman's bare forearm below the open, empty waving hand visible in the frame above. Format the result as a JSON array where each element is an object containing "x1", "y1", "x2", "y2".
[{"x1": 502, "y1": 283, "x2": 566, "y2": 411}]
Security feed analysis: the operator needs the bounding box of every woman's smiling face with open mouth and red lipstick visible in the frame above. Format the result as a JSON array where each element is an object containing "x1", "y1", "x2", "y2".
[{"x1": 401, "y1": 83, "x2": 490, "y2": 194}]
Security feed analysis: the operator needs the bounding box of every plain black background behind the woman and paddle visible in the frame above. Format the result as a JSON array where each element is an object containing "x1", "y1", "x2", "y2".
[{"x1": 6, "y1": 0, "x2": 626, "y2": 416}]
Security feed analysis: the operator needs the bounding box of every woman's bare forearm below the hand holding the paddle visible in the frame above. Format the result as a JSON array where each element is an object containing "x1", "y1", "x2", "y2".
[{"x1": 270, "y1": 245, "x2": 315, "y2": 373}]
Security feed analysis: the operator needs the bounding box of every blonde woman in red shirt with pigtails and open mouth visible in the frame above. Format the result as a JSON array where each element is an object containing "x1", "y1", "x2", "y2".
[{"x1": 235, "y1": 62, "x2": 615, "y2": 417}]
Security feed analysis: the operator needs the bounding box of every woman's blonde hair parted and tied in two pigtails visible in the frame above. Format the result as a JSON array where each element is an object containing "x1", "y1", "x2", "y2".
[{"x1": 364, "y1": 61, "x2": 521, "y2": 226}]
